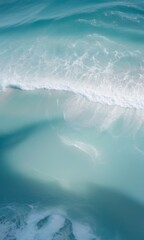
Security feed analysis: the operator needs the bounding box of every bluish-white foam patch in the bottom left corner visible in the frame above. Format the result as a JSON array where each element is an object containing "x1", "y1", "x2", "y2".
[{"x1": 0, "y1": 208, "x2": 99, "y2": 240}]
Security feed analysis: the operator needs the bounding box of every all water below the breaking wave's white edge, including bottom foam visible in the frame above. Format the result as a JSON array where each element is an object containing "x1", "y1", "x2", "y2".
[{"x1": 0, "y1": 89, "x2": 144, "y2": 239}]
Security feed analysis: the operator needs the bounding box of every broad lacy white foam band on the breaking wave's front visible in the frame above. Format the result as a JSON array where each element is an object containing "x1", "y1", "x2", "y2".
[{"x1": 0, "y1": 29, "x2": 144, "y2": 110}]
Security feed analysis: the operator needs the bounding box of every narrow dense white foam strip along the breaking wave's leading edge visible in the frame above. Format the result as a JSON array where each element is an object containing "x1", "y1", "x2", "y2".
[{"x1": 3, "y1": 79, "x2": 144, "y2": 110}]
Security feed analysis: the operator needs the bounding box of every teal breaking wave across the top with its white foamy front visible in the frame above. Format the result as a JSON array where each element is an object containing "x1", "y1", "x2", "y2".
[{"x1": 0, "y1": 0, "x2": 144, "y2": 110}]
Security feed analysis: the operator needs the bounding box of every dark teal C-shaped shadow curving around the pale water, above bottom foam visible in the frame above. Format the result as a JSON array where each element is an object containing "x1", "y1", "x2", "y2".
[{"x1": 0, "y1": 119, "x2": 144, "y2": 240}]
